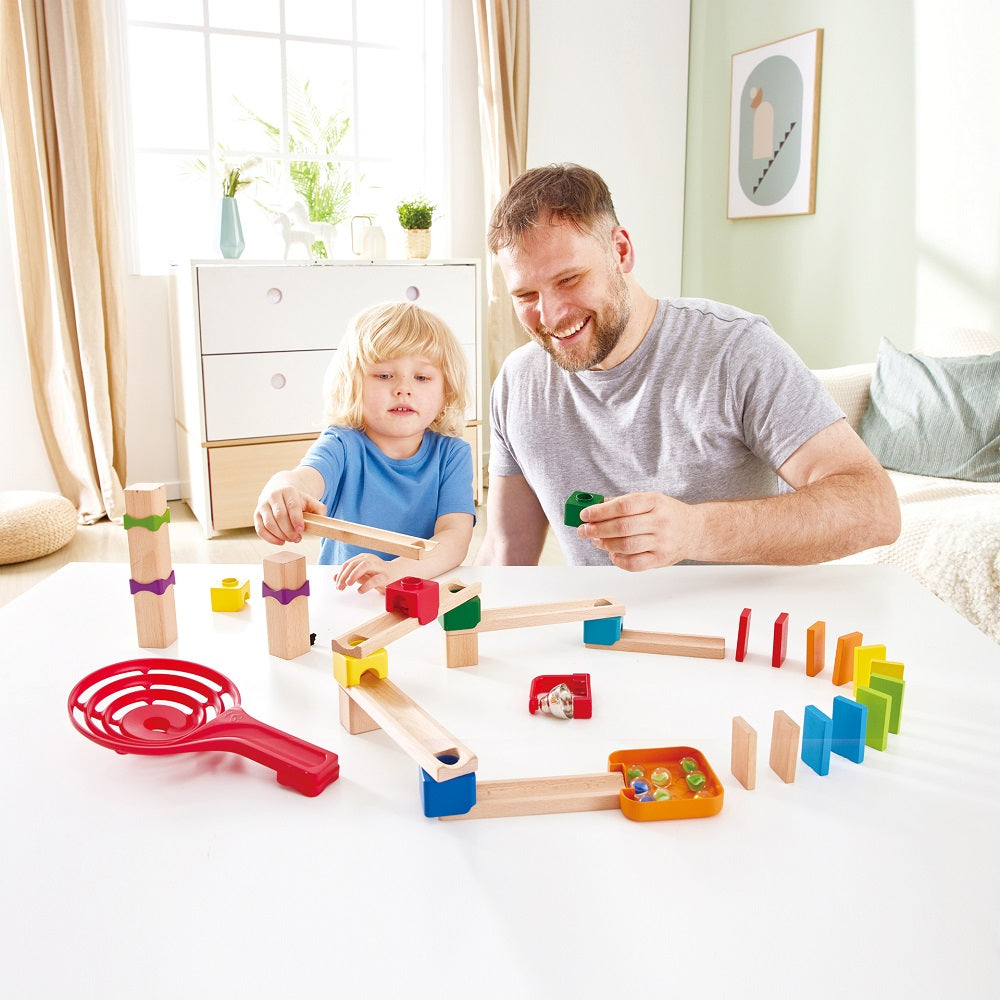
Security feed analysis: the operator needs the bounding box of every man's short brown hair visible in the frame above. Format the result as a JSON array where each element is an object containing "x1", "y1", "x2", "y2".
[{"x1": 486, "y1": 163, "x2": 618, "y2": 254}]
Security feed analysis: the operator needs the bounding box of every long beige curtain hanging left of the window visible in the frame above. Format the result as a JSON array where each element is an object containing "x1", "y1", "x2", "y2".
[{"x1": 0, "y1": 0, "x2": 126, "y2": 523}]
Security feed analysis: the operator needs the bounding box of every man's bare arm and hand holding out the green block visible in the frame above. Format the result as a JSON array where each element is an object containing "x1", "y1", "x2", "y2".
[{"x1": 578, "y1": 420, "x2": 900, "y2": 570}]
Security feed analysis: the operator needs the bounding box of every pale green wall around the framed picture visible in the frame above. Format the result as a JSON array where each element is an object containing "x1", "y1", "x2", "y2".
[{"x1": 683, "y1": 0, "x2": 1000, "y2": 367}]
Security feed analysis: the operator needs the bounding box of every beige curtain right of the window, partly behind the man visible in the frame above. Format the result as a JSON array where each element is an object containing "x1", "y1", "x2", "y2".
[{"x1": 474, "y1": 0, "x2": 528, "y2": 381}]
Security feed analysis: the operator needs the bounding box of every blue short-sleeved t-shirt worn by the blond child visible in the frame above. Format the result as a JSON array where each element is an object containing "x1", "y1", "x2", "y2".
[{"x1": 302, "y1": 427, "x2": 476, "y2": 566}]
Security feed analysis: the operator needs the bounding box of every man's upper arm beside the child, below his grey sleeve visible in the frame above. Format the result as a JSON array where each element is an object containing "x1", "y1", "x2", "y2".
[{"x1": 475, "y1": 476, "x2": 549, "y2": 566}]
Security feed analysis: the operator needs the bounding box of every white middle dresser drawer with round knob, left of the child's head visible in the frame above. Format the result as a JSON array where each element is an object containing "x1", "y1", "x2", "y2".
[{"x1": 202, "y1": 351, "x2": 335, "y2": 441}]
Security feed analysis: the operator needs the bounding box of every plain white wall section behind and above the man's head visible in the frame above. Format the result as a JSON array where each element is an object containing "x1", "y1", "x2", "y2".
[{"x1": 528, "y1": 0, "x2": 689, "y2": 296}]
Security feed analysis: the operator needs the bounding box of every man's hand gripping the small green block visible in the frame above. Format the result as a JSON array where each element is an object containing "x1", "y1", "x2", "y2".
[{"x1": 577, "y1": 493, "x2": 702, "y2": 571}]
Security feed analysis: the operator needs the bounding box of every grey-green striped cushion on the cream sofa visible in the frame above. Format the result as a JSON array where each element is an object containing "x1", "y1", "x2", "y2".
[{"x1": 858, "y1": 337, "x2": 1000, "y2": 483}]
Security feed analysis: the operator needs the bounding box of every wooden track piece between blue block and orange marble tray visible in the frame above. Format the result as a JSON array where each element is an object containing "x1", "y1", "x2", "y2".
[{"x1": 440, "y1": 771, "x2": 625, "y2": 820}]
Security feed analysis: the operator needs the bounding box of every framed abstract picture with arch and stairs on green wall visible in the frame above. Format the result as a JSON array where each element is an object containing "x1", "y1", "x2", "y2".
[{"x1": 727, "y1": 28, "x2": 823, "y2": 219}]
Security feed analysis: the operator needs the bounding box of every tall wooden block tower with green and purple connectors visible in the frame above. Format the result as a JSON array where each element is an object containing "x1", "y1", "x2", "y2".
[{"x1": 125, "y1": 483, "x2": 177, "y2": 649}]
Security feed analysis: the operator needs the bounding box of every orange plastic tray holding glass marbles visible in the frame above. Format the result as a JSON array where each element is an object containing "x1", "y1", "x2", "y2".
[{"x1": 608, "y1": 747, "x2": 724, "y2": 822}]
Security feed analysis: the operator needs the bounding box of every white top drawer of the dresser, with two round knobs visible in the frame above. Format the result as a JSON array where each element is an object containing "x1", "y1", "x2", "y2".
[{"x1": 198, "y1": 263, "x2": 477, "y2": 354}]
